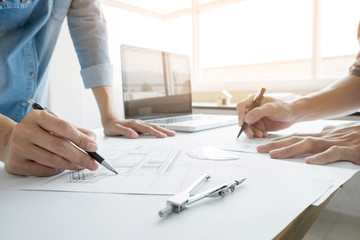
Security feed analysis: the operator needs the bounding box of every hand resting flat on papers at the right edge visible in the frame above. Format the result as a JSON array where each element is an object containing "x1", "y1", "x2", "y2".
[{"x1": 257, "y1": 123, "x2": 360, "y2": 164}]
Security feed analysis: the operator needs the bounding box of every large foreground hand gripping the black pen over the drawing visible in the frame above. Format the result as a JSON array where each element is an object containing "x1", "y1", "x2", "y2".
[{"x1": 1, "y1": 110, "x2": 98, "y2": 176}]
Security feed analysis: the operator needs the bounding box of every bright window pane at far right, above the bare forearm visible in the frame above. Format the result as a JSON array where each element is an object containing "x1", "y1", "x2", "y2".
[{"x1": 319, "y1": 0, "x2": 360, "y2": 78}]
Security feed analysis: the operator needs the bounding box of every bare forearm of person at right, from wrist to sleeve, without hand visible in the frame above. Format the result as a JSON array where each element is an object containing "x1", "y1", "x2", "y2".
[{"x1": 291, "y1": 75, "x2": 360, "y2": 122}]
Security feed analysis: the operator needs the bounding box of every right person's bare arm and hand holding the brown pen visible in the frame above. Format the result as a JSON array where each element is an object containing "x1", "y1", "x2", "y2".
[{"x1": 237, "y1": 75, "x2": 360, "y2": 138}]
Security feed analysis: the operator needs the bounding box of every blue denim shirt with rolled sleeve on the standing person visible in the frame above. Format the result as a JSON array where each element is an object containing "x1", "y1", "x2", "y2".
[{"x1": 0, "y1": 0, "x2": 112, "y2": 122}]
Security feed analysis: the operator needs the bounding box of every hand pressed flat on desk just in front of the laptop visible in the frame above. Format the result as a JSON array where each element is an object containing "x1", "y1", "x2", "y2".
[{"x1": 104, "y1": 119, "x2": 176, "y2": 138}]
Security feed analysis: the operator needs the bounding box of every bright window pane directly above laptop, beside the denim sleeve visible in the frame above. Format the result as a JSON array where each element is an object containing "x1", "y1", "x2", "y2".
[{"x1": 102, "y1": 5, "x2": 191, "y2": 65}]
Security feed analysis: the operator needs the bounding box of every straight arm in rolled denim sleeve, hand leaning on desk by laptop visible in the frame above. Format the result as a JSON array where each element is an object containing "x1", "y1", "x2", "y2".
[{"x1": 67, "y1": 0, "x2": 175, "y2": 138}]
